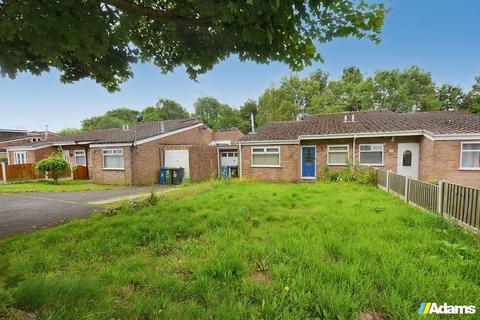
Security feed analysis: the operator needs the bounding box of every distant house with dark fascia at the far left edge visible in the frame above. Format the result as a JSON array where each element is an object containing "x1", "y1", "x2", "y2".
[{"x1": 0, "y1": 129, "x2": 59, "y2": 159}]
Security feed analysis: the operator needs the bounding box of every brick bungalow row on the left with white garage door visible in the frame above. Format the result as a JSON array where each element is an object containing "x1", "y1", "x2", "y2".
[{"x1": 7, "y1": 119, "x2": 242, "y2": 185}]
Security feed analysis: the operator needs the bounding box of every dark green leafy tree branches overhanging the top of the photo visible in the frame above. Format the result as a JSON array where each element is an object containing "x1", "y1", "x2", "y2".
[{"x1": 0, "y1": 0, "x2": 386, "y2": 91}]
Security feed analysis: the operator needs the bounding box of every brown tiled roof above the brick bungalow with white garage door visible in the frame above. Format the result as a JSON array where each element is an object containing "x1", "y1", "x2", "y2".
[{"x1": 13, "y1": 119, "x2": 202, "y2": 147}]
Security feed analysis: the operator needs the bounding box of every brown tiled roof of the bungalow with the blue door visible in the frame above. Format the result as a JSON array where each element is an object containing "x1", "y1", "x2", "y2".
[{"x1": 241, "y1": 110, "x2": 480, "y2": 141}]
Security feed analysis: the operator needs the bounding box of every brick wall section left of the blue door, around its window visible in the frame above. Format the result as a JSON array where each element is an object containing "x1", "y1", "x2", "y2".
[{"x1": 239, "y1": 144, "x2": 300, "y2": 182}]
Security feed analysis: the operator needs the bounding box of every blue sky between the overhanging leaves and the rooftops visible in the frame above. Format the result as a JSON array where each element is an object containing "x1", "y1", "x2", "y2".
[{"x1": 0, "y1": 0, "x2": 480, "y2": 131}]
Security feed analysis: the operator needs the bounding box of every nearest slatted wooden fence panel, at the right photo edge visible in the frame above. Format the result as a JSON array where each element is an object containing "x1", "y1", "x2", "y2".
[{"x1": 442, "y1": 182, "x2": 480, "y2": 228}]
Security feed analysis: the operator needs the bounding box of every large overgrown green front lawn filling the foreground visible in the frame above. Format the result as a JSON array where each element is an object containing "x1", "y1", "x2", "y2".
[{"x1": 0, "y1": 182, "x2": 480, "y2": 320}]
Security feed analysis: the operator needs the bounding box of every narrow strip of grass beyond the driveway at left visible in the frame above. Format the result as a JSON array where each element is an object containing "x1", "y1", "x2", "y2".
[{"x1": 0, "y1": 180, "x2": 124, "y2": 193}]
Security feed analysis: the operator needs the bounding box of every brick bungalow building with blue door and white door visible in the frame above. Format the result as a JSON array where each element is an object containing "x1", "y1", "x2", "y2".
[{"x1": 239, "y1": 110, "x2": 480, "y2": 188}]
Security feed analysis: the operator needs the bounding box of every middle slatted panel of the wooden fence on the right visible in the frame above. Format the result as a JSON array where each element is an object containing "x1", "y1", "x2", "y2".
[{"x1": 408, "y1": 179, "x2": 438, "y2": 212}]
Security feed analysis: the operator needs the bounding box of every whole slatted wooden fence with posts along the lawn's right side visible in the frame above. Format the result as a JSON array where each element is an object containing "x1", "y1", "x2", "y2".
[{"x1": 377, "y1": 170, "x2": 480, "y2": 230}]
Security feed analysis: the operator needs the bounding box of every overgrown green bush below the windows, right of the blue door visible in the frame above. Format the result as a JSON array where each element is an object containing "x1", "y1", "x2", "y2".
[{"x1": 322, "y1": 164, "x2": 377, "y2": 184}]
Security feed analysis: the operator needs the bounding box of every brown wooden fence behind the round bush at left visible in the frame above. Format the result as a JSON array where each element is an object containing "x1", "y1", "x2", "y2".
[{"x1": 0, "y1": 163, "x2": 88, "y2": 183}]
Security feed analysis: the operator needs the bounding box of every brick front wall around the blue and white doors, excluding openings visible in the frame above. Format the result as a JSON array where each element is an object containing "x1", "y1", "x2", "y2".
[{"x1": 242, "y1": 136, "x2": 480, "y2": 188}]
